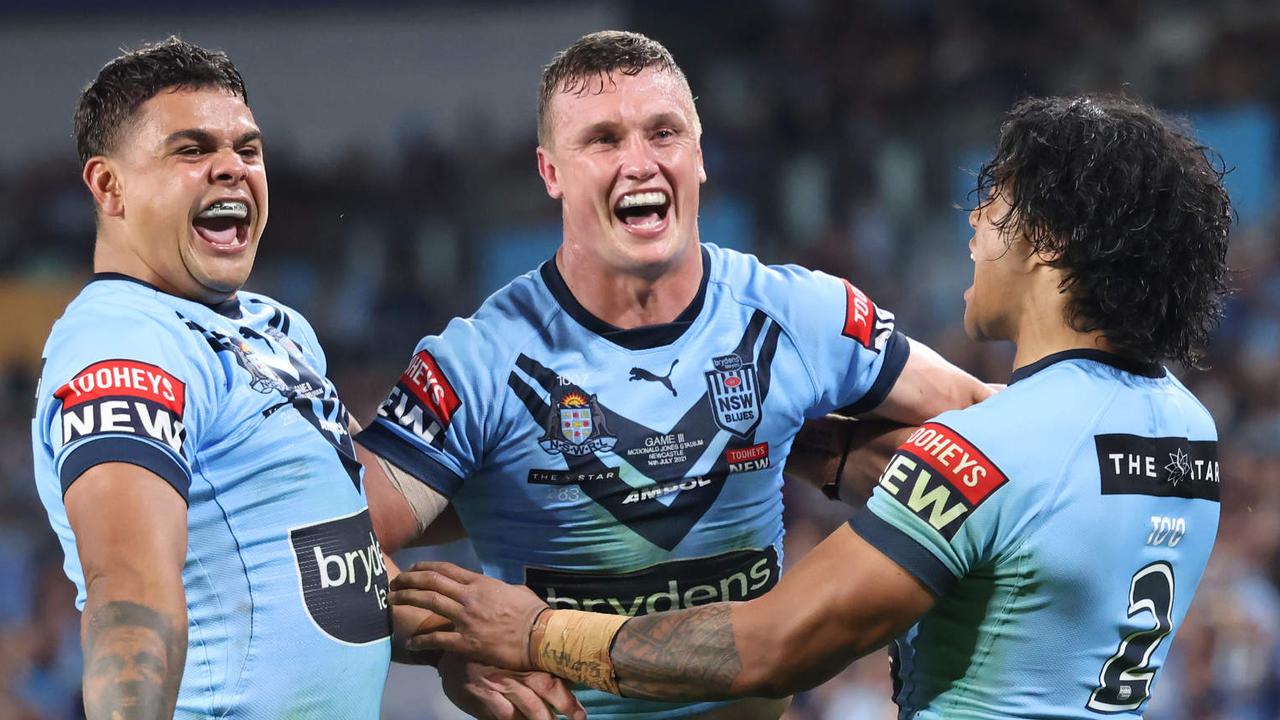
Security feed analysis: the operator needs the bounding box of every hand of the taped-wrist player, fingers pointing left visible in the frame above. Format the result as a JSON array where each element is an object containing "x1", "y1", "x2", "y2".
[{"x1": 390, "y1": 562, "x2": 547, "y2": 670}]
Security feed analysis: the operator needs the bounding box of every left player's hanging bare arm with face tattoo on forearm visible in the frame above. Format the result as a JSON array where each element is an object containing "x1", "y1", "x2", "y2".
[{"x1": 65, "y1": 462, "x2": 187, "y2": 720}]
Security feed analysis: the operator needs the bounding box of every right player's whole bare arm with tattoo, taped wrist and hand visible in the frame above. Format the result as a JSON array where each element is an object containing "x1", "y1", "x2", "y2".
[{"x1": 392, "y1": 525, "x2": 934, "y2": 701}]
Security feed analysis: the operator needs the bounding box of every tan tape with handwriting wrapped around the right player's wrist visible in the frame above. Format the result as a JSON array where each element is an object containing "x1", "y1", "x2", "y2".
[{"x1": 529, "y1": 610, "x2": 630, "y2": 694}]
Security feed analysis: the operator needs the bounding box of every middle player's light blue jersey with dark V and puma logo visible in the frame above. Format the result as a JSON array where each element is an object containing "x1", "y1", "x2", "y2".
[{"x1": 357, "y1": 246, "x2": 908, "y2": 720}]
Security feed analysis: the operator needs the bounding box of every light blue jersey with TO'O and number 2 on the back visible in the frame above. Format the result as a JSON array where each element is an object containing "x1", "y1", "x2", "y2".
[{"x1": 851, "y1": 350, "x2": 1219, "y2": 720}]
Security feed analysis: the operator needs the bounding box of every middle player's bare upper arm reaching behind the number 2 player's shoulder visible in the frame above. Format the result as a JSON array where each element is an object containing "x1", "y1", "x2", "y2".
[{"x1": 869, "y1": 340, "x2": 993, "y2": 425}]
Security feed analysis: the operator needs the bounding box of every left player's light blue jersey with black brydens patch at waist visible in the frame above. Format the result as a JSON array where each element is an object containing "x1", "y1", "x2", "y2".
[{"x1": 32, "y1": 274, "x2": 390, "y2": 720}]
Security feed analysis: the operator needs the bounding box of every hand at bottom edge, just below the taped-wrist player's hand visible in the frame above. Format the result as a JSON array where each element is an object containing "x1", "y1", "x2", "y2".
[{"x1": 438, "y1": 653, "x2": 586, "y2": 720}]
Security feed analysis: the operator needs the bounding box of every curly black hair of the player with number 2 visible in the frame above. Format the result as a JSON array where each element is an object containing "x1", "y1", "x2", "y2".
[{"x1": 975, "y1": 96, "x2": 1234, "y2": 368}]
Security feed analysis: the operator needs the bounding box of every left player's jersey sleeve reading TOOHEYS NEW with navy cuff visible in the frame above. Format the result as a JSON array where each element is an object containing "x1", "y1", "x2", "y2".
[{"x1": 37, "y1": 306, "x2": 218, "y2": 500}]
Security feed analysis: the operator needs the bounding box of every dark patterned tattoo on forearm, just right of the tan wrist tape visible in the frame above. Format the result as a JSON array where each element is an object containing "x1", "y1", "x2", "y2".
[{"x1": 609, "y1": 603, "x2": 742, "y2": 700}]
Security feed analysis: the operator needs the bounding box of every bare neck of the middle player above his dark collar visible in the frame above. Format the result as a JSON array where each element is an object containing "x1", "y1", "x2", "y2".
[{"x1": 556, "y1": 245, "x2": 703, "y2": 329}]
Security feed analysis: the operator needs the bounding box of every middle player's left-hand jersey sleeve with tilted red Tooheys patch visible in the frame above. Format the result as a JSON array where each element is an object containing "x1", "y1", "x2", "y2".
[{"x1": 356, "y1": 320, "x2": 498, "y2": 497}]
